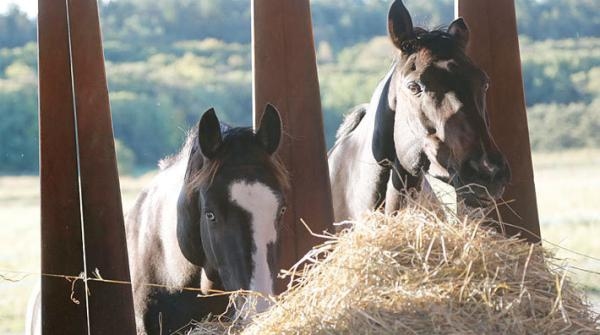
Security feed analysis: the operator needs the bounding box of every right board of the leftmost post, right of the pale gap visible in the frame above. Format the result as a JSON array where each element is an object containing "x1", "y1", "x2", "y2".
[{"x1": 67, "y1": 0, "x2": 135, "y2": 334}]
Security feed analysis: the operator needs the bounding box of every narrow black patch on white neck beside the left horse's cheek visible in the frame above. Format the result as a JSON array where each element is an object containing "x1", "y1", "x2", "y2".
[{"x1": 177, "y1": 192, "x2": 205, "y2": 266}]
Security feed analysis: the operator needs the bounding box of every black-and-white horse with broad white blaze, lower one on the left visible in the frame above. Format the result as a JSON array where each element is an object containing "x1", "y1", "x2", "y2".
[{"x1": 126, "y1": 105, "x2": 287, "y2": 334}]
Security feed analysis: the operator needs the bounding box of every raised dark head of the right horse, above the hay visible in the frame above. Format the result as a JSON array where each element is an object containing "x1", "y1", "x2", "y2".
[{"x1": 388, "y1": 0, "x2": 510, "y2": 206}]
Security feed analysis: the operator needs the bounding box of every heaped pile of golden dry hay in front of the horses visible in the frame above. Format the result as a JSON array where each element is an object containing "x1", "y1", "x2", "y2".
[{"x1": 196, "y1": 206, "x2": 600, "y2": 334}]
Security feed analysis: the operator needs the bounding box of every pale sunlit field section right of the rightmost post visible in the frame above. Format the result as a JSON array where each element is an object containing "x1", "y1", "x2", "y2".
[{"x1": 533, "y1": 150, "x2": 600, "y2": 311}]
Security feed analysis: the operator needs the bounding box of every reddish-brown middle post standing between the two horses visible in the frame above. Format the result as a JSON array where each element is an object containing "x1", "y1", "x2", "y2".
[{"x1": 252, "y1": 0, "x2": 333, "y2": 291}]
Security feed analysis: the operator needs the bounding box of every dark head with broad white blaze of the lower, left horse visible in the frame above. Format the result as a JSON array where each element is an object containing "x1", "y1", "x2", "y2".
[{"x1": 178, "y1": 105, "x2": 287, "y2": 307}]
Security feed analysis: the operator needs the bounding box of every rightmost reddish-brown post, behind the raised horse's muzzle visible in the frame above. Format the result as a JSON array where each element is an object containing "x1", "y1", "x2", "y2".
[{"x1": 456, "y1": 0, "x2": 540, "y2": 242}]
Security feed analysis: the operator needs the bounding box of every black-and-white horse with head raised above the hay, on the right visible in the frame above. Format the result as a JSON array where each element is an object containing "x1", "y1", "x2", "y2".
[{"x1": 329, "y1": 0, "x2": 510, "y2": 222}]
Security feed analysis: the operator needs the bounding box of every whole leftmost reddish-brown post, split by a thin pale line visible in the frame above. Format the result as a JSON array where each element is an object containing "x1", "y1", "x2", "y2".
[{"x1": 38, "y1": 0, "x2": 136, "y2": 334}]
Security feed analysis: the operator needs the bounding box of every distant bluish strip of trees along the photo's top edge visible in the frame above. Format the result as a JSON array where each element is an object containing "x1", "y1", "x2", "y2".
[{"x1": 0, "y1": 0, "x2": 600, "y2": 51}]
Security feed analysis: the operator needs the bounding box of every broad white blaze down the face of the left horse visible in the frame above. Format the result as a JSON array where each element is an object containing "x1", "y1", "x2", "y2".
[{"x1": 229, "y1": 181, "x2": 279, "y2": 295}]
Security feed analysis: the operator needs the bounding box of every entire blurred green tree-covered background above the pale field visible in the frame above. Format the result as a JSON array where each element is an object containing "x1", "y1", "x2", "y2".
[{"x1": 0, "y1": 0, "x2": 600, "y2": 174}]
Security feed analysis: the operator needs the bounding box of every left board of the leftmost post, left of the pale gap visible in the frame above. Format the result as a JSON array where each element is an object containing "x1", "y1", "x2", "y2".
[{"x1": 38, "y1": 0, "x2": 87, "y2": 335}]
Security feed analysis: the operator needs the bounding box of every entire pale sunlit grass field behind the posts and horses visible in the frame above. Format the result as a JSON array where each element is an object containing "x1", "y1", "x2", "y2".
[{"x1": 0, "y1": 150, "x2": 600, "y2": 335}]
